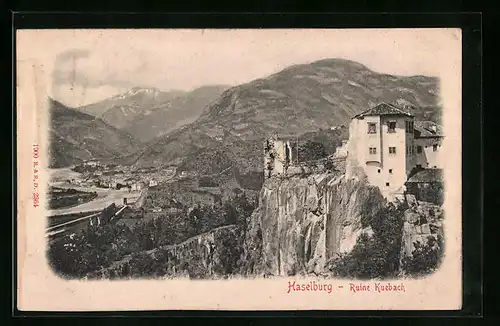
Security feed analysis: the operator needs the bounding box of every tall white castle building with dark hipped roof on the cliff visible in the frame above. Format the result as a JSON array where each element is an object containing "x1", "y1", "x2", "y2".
[{"x1": 346, "y1": 103, "x2": 443, "y2": 197}]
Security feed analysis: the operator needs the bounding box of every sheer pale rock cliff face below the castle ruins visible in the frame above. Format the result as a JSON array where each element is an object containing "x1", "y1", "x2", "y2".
[{"x1": 243, "y1": 173, "x2": 385, "y2": 276}]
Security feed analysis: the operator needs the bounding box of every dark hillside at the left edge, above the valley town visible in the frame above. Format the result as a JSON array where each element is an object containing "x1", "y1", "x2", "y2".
[{"x1": 49, "y1": 98, "x2": 139, "y2": 168}]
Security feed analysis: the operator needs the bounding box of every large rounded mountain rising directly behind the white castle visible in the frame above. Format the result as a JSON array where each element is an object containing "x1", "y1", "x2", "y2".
[{"x1": 129, "y1": 59, "x2": 440, "y2": 178}]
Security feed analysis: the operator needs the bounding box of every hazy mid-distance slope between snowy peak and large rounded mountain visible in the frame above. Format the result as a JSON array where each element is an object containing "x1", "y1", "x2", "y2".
[{"x1": 123, "y1": 85, "x2": 229, "y2": 141}]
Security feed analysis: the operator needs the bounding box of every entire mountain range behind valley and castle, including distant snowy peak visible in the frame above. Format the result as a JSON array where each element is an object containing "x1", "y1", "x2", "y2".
[{"x1": 51, "y1": 59, "x2": 441, "y2": 185}]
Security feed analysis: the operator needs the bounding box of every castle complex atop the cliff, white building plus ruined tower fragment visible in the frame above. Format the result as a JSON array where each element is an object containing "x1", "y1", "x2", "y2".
[{"x1": 264, "y1": 103, "x2": 444, "y2": 198}]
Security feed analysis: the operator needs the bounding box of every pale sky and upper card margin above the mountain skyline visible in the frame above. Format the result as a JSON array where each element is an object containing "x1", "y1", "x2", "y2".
[{"x1": 17, "y1": 29, "x2": 461, "y2": 107}]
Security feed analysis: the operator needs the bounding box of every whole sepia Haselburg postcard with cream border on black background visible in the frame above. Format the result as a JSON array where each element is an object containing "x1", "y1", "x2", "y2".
[{"x1": 17, "y1": 29, "x2": 461, "y2": 309}]
